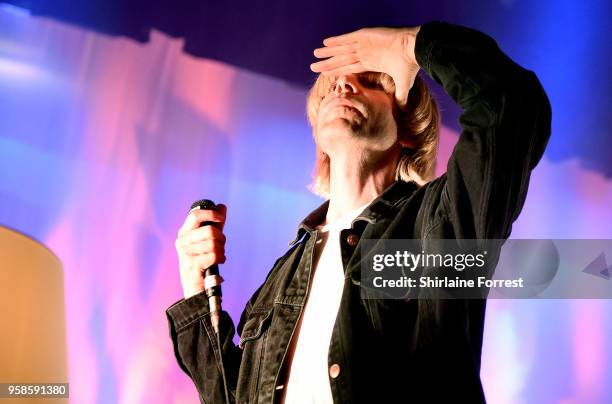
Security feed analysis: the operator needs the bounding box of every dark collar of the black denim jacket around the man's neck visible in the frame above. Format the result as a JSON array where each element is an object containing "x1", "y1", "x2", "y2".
[{"x1": 289, "y1": 180, "x2": 418, "y2": 247}]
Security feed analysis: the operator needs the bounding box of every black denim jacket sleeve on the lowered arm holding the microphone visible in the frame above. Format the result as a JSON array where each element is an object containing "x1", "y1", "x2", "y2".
[{"x1": 166, "y1": 292, "x2": 251, "y2": 403}]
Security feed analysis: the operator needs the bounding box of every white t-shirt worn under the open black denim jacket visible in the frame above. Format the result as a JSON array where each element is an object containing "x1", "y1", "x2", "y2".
[{"x1": 283, "y1": 203, "x2": 369, "y2": 404}]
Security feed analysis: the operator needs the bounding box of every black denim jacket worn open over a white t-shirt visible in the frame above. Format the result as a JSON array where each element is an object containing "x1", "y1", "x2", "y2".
[{"x1": 166, "y1": 22, "x2": 551, "y2": 403}]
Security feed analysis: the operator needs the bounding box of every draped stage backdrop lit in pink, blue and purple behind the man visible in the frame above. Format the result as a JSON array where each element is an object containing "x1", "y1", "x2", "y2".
[{"x1": 0, "y1": 7, "x2": 612, "y2": 404}]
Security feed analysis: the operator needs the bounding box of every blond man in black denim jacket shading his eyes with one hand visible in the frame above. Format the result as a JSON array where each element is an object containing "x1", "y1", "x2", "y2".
[{"x1": 167, "y1": 22, "x2": 551, "y2": 403}]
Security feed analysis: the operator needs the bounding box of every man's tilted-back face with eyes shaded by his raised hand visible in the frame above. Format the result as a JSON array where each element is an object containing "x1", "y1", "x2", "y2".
[{"x1": 317, "y1": 73, "x2": 398, "y2": 156}]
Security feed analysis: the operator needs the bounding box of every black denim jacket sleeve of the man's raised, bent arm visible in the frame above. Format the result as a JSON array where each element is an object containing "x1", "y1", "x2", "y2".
[{"x1": 415, "y1": 21, "x2": 551, "y2": 239}]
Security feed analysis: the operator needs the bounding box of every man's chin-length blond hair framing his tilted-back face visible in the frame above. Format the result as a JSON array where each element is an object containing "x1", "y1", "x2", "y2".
[{"x1": 306, "y1": 72, "x2": 440, "y2": 198}]
